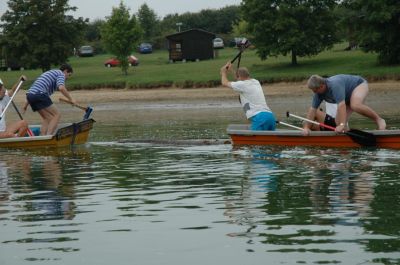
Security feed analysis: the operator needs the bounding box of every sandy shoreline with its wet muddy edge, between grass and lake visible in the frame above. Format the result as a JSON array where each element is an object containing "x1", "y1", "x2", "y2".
[{"x1": 7, "y1": 81, "x2": 400, "y2": 124}]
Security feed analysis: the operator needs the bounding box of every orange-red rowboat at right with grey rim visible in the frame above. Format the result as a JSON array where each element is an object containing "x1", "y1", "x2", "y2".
[{"x1": 227, "y1": 124, "x2": 400, "y2": 149}]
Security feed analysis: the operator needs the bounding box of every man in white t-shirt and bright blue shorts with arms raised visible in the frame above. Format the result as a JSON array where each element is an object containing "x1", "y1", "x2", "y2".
[{"x1": 220, "y1": 62, "x2": 276, "y2": 131}]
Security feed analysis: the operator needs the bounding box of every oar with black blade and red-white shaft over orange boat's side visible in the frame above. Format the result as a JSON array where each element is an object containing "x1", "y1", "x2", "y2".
[{"x1": 286, "y1": 111, "x2": 376, "y2": 146}]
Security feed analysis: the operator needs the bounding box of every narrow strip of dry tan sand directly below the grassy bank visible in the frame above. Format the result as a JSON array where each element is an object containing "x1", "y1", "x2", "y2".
[{"x1": 15, "y1": 81, "x2": 400, "y2": 104}]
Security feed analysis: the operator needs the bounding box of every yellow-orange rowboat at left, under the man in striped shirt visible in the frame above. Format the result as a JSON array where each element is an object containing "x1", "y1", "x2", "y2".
[{"x1": 0, "y1": 119, "x2": 95, "y2": 149}]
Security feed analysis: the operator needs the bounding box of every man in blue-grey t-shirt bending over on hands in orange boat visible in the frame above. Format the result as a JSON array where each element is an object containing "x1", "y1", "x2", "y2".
[{"x1": 304, "y1": 74, "x2": 386, "y2": 135}]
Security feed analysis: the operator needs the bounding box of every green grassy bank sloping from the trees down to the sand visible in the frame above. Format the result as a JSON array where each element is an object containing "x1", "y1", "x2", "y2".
[{"x1": 0, "y1": 42, "x2": 400, "y2": 89}]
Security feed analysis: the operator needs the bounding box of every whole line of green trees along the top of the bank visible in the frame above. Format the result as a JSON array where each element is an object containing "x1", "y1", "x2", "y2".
[{"x1": 0, "y1": 0, "x2": 400, "y2": 71}]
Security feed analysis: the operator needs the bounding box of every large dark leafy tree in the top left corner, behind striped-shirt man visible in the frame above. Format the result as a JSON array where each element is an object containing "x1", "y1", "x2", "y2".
[{"x1": 0, "y1": 0, "x2": 86, "y2": 71}]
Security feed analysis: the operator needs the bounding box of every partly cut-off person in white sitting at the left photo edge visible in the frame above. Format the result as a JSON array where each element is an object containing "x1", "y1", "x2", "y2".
[{"x1": 0, "y1": 76, "x2": 28, "y2": 138}]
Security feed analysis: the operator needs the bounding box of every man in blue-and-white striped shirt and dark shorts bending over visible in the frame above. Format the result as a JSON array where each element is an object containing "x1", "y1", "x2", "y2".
[{"x1": 24, "y1": 64, "x2": 76, "y2": 135}]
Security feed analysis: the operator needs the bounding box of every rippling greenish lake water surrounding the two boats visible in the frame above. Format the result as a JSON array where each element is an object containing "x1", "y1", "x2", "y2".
[{"x1": 0, "y1": 103, "x2": 400, "y2": 265}]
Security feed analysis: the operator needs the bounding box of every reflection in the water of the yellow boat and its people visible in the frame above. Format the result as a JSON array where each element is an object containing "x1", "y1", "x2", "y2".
[{"x1": 0, "y1": 147, "x2": 90, "y2": 222}]
